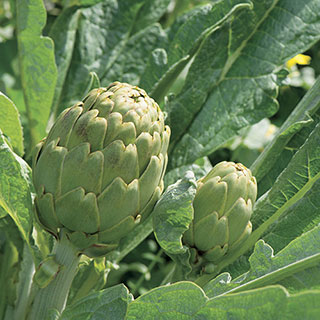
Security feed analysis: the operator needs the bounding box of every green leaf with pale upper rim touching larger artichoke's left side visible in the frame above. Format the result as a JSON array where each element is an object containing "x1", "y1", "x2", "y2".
[{"x1": 0, "y1": 132, "x2": 32, "y2": 244}]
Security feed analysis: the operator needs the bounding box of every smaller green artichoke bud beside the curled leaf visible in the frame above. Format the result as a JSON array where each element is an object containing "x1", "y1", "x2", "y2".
[{"x1": 183, "y1": 161, "x2": 257, "y2": 263}]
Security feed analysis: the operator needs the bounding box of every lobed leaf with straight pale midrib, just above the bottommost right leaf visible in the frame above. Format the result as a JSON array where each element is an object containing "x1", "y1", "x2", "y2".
[{"x1": 204, "y1": 226, "x2": 320, "y2": 298}]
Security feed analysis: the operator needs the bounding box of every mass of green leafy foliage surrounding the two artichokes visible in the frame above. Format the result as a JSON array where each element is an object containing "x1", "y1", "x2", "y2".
[{"x1": 0, "y1": 0, "x2": 320, "y2": 319}]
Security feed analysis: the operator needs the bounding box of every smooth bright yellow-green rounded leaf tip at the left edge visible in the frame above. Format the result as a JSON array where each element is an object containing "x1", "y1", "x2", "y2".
[{"x1": 0, "y1": 92, "x2": 23, "y2": 156}]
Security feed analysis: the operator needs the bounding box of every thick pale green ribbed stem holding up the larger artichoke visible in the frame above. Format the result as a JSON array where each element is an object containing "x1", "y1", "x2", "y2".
[{"x1": 28, "y1": 231, "x2": 80, "y2": 320}]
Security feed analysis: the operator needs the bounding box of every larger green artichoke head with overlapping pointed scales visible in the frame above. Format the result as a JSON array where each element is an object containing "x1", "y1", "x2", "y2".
[{"x1": 33, "y1": 82, "x2": 170, "y2": 257}]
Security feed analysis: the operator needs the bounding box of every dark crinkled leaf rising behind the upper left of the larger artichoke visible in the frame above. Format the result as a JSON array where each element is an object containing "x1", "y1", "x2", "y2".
[{"x1": 58, "y1": 0, "x2": 142, "y2": 113}]
